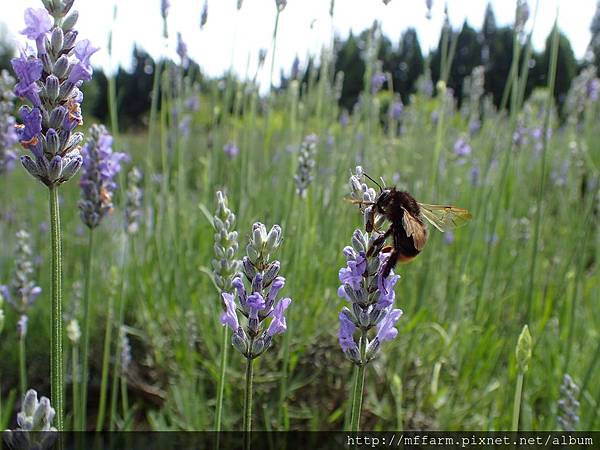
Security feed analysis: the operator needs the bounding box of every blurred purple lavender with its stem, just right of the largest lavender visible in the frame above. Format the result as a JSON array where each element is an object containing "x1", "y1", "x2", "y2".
[{"x1": 78, "y1": 125, "x2": 126, "y2": 429}]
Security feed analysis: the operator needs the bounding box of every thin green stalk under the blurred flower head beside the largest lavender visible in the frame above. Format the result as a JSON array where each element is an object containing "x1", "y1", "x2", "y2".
[{"x1": 77, "y1": 228, "x2": 94, "y2": 431}]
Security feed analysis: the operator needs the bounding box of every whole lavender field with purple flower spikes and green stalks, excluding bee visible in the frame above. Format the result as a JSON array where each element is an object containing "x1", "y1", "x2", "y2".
[{"x1": 0, "y1": 0, "x2": 600, "y2": 439}]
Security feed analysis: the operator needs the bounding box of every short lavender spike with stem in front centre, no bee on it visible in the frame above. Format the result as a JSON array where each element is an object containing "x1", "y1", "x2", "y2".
[{"x1": 221, "y1": 222, "x2": 292, "y2": 432}]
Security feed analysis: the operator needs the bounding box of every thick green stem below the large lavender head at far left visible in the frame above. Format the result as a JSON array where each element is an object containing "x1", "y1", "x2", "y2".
[{"x1": 50, "y1": 187, "x2": 64, "y2": 431}]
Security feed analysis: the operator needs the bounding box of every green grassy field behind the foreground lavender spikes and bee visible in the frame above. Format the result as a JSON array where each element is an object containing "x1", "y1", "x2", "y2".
[{"x1": 0, "y1": 0, "x2": 600, "y2": 436}]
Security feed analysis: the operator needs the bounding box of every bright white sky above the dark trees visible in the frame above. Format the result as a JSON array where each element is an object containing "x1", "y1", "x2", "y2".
[{"x1": 0, "y1": 0, "x2": 596, "y2": 85}]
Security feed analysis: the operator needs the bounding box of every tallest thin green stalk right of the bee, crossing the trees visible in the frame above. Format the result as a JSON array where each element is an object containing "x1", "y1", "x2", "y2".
[{"x1": 525, "y1": 21, "x2": 558, "y2": 322}]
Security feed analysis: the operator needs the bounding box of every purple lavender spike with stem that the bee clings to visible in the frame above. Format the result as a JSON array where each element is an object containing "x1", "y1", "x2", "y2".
[{"x1": 338, "y1": 166, "x2": 402, "y2": 431}]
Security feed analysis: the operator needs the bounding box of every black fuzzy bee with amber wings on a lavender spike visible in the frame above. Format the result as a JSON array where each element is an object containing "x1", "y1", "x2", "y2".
[{"x1": 353, "y1": 174, "x2": 472, "y2": 277}]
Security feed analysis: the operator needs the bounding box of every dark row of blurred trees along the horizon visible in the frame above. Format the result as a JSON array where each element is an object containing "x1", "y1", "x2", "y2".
[{"x1": 0, "y1": 4, "x2": 600, "y2": 128}]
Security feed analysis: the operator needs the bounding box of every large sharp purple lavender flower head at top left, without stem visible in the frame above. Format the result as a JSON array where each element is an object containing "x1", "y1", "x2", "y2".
[{"x1": 11, "y1": 0, "x2": 97, "y2": 188}]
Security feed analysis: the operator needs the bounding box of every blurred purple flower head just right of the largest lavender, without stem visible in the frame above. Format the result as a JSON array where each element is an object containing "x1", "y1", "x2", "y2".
[{"x1": 79, "y1": 125, "x2": 126, "y2": 228}]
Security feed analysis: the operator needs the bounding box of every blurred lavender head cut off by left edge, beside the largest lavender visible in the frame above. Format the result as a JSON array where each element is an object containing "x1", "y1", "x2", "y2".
[{"x1": 0, "y1": 70, "x2": 19, "y2": 175}]
